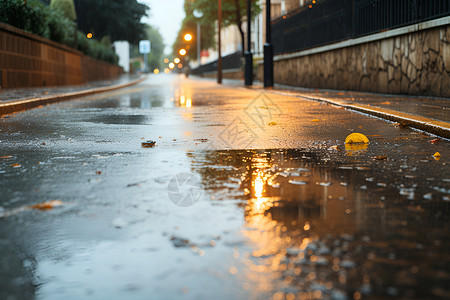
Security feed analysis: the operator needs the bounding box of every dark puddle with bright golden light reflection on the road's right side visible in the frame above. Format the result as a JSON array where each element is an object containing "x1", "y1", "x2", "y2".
[{"x1": 190, "y1": 150, "x2": 450, "y2": 299}]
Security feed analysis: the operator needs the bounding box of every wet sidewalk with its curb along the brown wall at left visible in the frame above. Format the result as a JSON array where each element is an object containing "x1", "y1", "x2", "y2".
[{"x1": 0, "y1": 75, "x2": 145, "y2": 116}]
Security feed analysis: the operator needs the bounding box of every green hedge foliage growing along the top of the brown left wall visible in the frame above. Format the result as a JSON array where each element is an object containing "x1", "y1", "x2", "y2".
[{"x1": 0, "y1": 0, "x2": 118, "y2": 64}]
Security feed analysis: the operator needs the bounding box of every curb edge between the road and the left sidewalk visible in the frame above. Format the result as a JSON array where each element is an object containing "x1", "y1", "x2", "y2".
[{"x1": 0, "y1": 76, "x2": 147, "y2": 116}]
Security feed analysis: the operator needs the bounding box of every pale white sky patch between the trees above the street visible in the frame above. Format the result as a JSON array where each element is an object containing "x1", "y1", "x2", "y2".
[{"x1": 138, "y1": 0, "x2": 184, "y2": 53}]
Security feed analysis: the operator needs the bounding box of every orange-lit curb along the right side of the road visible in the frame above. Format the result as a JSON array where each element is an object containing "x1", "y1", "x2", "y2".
[{"x1": 270, "y1": 90, "x2": 450, "y2": 139}]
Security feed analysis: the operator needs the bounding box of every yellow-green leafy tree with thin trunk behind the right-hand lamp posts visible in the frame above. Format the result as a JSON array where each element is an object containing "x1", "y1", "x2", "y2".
[{"x1": 193, "y1": 0, "x2": 261, "y2": 52}]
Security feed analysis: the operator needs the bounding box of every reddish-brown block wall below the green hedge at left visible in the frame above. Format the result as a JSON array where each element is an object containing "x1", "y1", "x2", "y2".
[{"x1": 0, "y1": 23, "x2": 122, "y2": 88}]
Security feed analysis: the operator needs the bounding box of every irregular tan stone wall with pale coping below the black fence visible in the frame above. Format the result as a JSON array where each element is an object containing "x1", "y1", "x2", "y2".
[{"x1": 258, "y1": 18, "x2": 450, "y2": 97}]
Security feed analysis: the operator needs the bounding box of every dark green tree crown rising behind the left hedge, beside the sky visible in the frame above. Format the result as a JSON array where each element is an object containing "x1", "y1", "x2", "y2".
[{"x1": 75, "y1": 0, "x2": 149, "y2": 44}]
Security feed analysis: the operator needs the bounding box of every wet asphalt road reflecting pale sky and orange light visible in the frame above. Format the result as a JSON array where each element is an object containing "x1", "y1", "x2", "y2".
[{"x1": 0, "y1": 75, "x2": 450, "y2": 299}]
